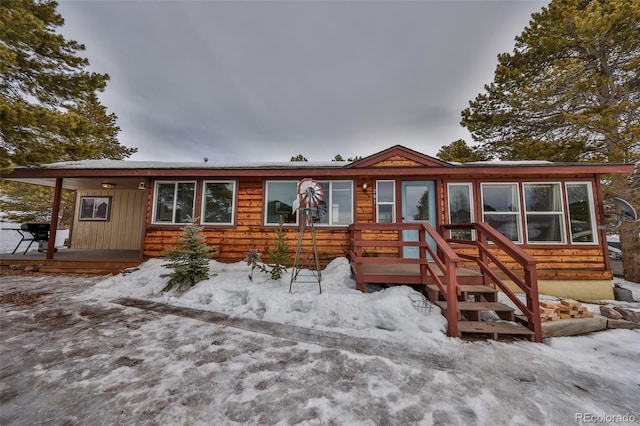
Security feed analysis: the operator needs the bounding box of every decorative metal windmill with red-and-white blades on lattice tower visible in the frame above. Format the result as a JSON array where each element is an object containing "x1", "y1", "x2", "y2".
[{"x1": 289, "y1": 178, "x2": 324, "y2": 293}]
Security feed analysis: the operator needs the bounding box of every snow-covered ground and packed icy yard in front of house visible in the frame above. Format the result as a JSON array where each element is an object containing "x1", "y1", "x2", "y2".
[{"x1": 0, "y1": 259, "x2": 640, "y2": 425}]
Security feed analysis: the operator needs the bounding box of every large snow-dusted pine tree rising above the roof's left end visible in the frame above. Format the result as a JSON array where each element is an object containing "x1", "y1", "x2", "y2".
[{"x1": 0, "y1": 0, "x2": 136, "y2": 171}]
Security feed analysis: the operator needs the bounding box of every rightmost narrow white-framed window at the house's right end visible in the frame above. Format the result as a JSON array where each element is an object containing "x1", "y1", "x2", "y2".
[{"x1": 566, "y1": 182, "x2": 597, "y2": 243}]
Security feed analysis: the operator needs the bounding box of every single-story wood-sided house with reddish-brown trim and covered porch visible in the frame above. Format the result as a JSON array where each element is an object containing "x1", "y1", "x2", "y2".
[{"x1": 2, "y1": 145, "x2": 632, "y2": 342}]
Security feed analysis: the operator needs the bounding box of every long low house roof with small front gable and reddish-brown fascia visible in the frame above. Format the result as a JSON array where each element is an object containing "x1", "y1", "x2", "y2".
[{"x1": 2, "y1": 145, "x2": 633, "y2": 186}]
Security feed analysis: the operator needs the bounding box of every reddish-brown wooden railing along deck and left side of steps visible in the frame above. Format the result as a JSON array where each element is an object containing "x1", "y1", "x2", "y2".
[{"x1": 349, "y1": 222, "x2": 461, "y2": 337}]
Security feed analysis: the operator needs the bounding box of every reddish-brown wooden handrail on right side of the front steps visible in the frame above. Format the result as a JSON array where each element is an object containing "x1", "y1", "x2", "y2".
[{"x1": 441, "y1": 223, "x2": 542, "y2": 342}]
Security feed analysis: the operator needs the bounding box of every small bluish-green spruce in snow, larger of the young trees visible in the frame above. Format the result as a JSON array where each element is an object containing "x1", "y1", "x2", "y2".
[{"x1": 162, "y1": 217, "x2": 215, "y2": 292}]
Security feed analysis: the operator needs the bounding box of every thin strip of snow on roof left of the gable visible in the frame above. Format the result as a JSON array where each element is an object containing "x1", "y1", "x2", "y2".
[{"x1": 41, "y1": 160, "x2": 350, "y2": 169}]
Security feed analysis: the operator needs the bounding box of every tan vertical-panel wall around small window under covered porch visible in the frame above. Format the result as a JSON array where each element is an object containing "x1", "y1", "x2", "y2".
[{"x1": 70, "y1": 190, "x2": 145, "y2": 250}]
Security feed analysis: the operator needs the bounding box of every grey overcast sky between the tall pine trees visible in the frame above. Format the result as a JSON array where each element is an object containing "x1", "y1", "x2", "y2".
[{"x1": 58, "y1": 0, "x2": 548, "y2": 162}]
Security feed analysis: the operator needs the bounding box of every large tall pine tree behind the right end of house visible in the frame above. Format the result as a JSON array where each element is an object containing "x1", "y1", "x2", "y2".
[{"x1": 461, "y1": 0, "x2": 640, "y2": 282}]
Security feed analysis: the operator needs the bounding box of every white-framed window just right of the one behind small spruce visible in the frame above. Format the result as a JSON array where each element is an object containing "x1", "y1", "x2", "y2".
[{"x1": 201, "y1": 181, "x2": 236, "y2": 225}]
